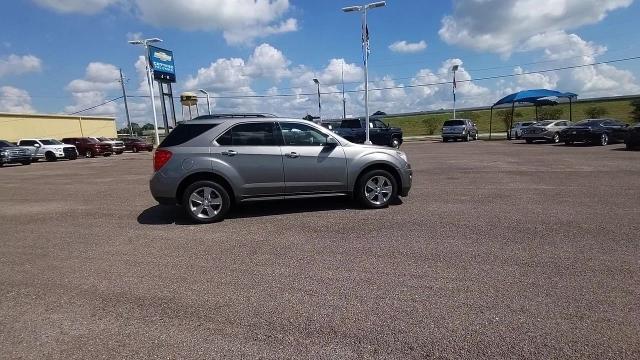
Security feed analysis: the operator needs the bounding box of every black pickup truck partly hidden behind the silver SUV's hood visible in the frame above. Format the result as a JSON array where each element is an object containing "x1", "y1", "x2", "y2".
[{"x1": 333, "y1": 118, "x2": 402, "y2": 148}]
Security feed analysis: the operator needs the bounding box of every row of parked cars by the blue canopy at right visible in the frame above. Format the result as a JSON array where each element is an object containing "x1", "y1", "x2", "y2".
[{"x1": 512, "y1": 119, "x2": 640, "y2": 149}]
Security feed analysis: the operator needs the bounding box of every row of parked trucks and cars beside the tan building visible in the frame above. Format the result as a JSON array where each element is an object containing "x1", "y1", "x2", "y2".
[{"x1": 0, "y1": 137, "x2": 153, "y2": 166}]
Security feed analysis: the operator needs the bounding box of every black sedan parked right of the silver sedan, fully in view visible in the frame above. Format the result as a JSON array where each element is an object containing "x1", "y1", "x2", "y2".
[{"x1": 560, "y1": 119, "x2": 629, "y2": 146}]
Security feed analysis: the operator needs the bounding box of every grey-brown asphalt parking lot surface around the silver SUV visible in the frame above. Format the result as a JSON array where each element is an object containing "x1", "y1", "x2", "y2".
[{"x1": 0, "y1": 141, "x2": 640, "y2": 359}]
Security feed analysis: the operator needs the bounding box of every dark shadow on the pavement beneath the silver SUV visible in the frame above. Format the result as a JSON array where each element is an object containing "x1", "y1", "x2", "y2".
[{"x1": 138, "y1": 196, "x2": 402, "y2": 225}]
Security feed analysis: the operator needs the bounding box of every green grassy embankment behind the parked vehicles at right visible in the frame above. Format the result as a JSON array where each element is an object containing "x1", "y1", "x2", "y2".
[{"x1": 384, "y1": 100, "x2": 633, "y2": 136}]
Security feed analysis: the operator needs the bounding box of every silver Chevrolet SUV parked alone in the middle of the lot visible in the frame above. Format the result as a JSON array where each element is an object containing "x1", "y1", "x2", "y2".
[{"x1": 150, "y1": 114, "x2": 412, "y2": 223}]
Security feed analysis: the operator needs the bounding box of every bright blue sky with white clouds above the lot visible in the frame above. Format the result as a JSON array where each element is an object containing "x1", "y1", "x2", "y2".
[{"x1": 0, "y1": 0, "x2": 640, "y2": 124}]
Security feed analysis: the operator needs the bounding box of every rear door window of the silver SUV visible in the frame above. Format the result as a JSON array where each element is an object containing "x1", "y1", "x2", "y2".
[{"x1": 216, "y1": 122, "x2": 278, "y2": 146}]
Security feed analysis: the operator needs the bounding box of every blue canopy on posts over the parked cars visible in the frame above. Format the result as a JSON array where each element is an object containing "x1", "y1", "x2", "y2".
[{"x1": 489, "y1": 89, "x2": 578, "y2": 139}]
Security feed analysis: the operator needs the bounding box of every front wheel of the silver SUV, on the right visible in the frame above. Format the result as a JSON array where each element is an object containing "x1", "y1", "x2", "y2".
[{"x1": 355, "y1": 170, "x2": 398, "y2": 209}]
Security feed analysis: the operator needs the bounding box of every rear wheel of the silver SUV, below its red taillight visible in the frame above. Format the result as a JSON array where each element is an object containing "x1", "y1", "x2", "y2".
[{"x1": 182, "y1": 180, "x2": 231, "y2": 224}]
